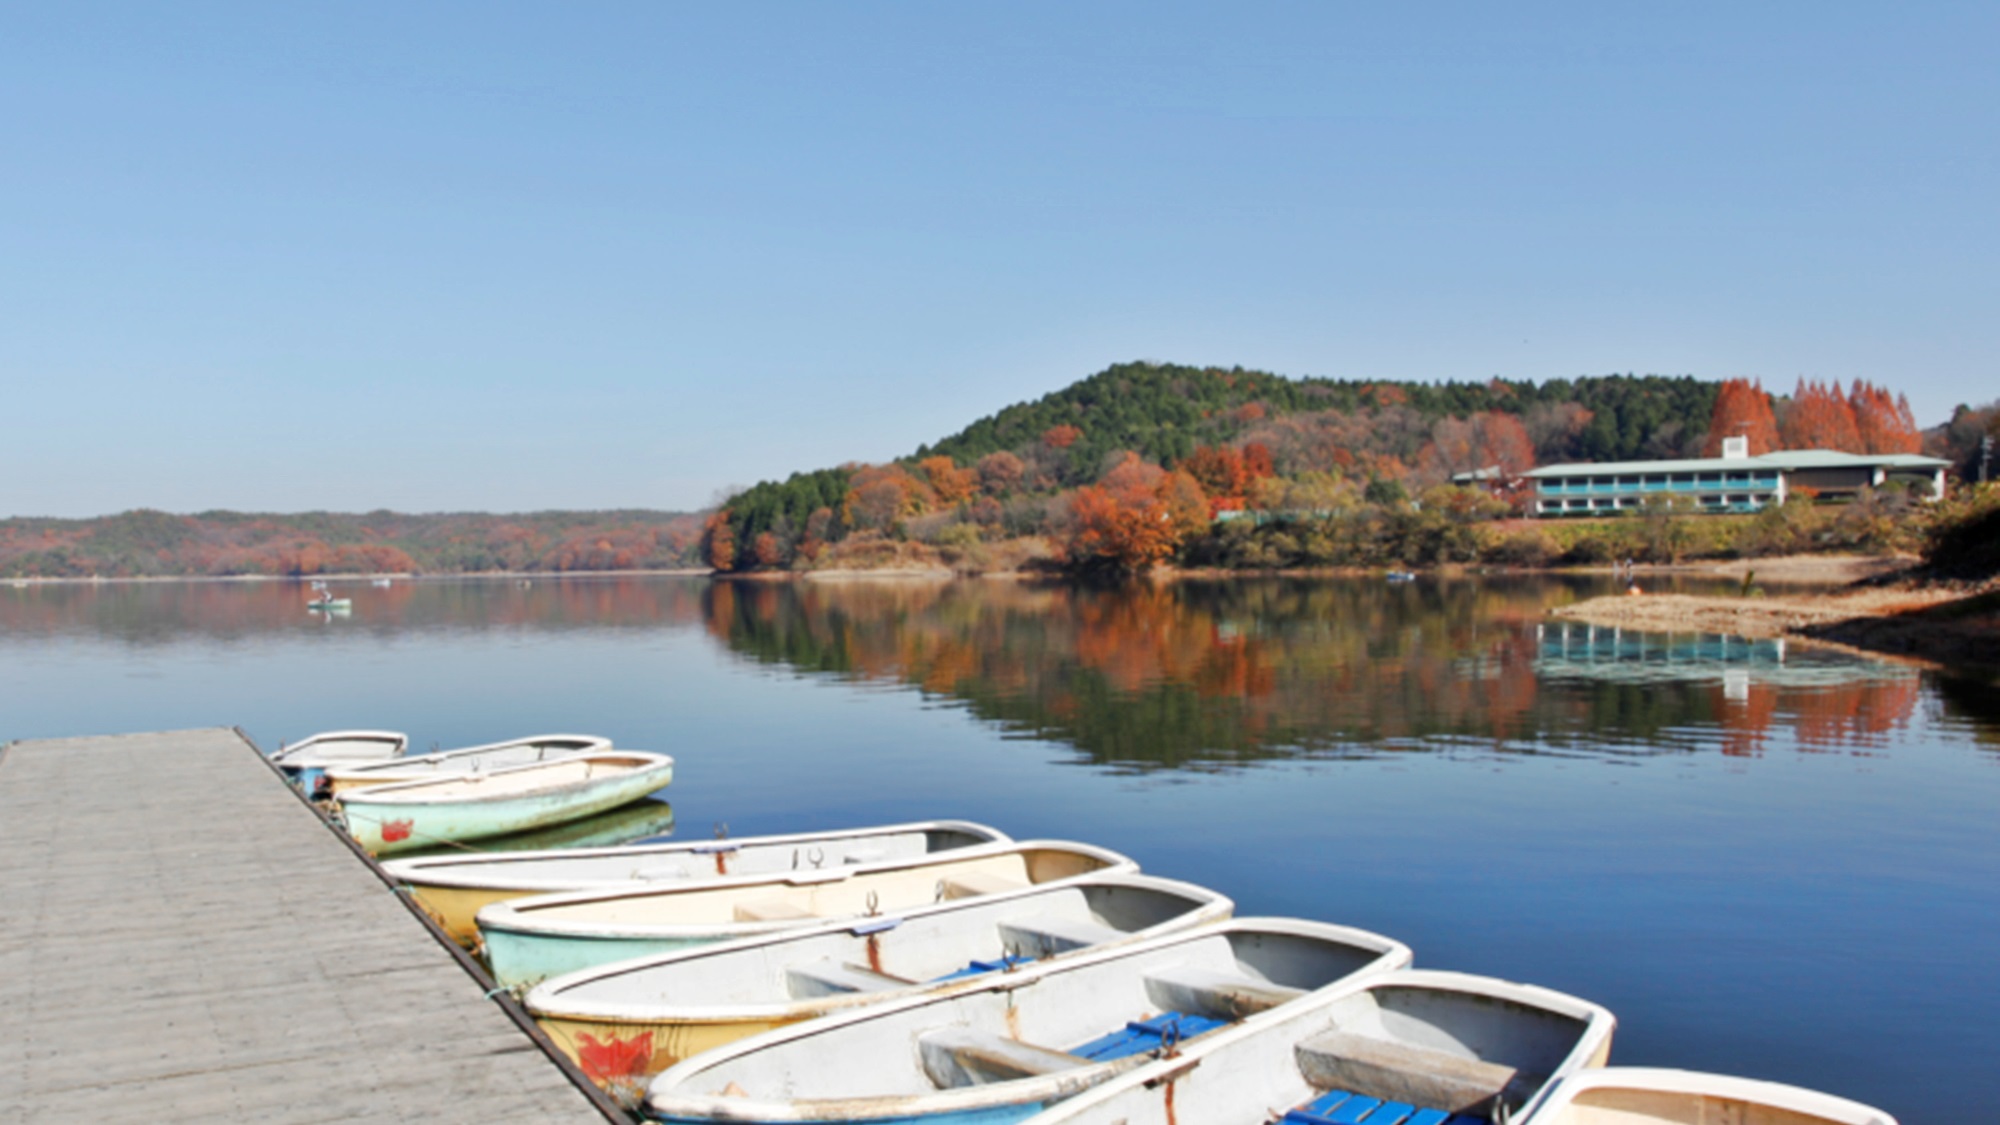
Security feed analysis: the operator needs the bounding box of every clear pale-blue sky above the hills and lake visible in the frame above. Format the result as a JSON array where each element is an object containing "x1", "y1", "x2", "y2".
[{"x1": 0, "y1": 2, "x2": 2000, "y2": 514}]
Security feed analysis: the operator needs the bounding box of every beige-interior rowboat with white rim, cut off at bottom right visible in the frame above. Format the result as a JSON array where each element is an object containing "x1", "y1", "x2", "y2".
[{"x1": 1520, "y1": 1067, "x2": 1896, "y2": 1125}]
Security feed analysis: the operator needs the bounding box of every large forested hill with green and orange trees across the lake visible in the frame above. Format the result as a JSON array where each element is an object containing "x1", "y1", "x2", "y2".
[{"x1": 702, "y1": 362, "x2": 1720, "y2": 571}]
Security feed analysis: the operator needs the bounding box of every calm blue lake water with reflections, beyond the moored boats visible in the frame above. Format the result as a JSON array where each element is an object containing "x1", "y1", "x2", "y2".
[{"x1": 0, "y1": 579, "x2": 2000, "y2": 1123}]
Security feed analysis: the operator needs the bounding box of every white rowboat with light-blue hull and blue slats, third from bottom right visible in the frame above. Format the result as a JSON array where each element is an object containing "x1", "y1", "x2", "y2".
[{"x1": 646, "y1": 919, "x2": 1410, "y2": 1125}]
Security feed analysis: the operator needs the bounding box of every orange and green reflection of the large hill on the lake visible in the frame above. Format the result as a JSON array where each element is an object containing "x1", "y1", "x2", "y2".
[{"x1": 706, "y1": 579, "x2": 1918, "y2": 769}]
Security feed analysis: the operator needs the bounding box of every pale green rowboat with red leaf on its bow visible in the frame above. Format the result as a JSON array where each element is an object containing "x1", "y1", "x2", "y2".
[{"x1": 334, "y1": 751, "x2": 674, "y2": 855}]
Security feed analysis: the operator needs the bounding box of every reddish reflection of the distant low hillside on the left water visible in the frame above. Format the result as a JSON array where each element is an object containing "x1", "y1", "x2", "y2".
[{"x1": 0, "y1": 577, "x2": 706, "y2": 645}]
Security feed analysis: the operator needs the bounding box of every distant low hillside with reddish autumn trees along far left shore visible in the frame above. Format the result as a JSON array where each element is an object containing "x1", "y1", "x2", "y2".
[{"x1": 0, "y1": 510, "x2": 702, "y2": 579}]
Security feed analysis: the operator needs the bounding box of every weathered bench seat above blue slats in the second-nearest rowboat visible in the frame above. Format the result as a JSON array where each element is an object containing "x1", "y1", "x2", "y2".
[{"x1": 1294, "y1": 1029, "x2": 1546, "y2": 1117}]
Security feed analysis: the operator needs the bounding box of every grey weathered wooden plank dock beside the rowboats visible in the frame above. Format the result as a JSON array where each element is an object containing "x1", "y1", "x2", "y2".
[{"x1": 0, "y1": 729, "x2": 624, "y2": 1125}]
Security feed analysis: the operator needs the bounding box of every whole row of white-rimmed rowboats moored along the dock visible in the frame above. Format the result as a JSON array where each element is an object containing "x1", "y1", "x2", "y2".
[{"x1": 262, "y1": 733, "x2": 1894, "y2": 1125}]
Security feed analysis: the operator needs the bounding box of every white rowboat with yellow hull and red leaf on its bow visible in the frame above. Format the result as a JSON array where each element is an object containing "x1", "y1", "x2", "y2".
[{"x1": 522, "y1": 873, "x2": 1234, "y2": 1101}]
